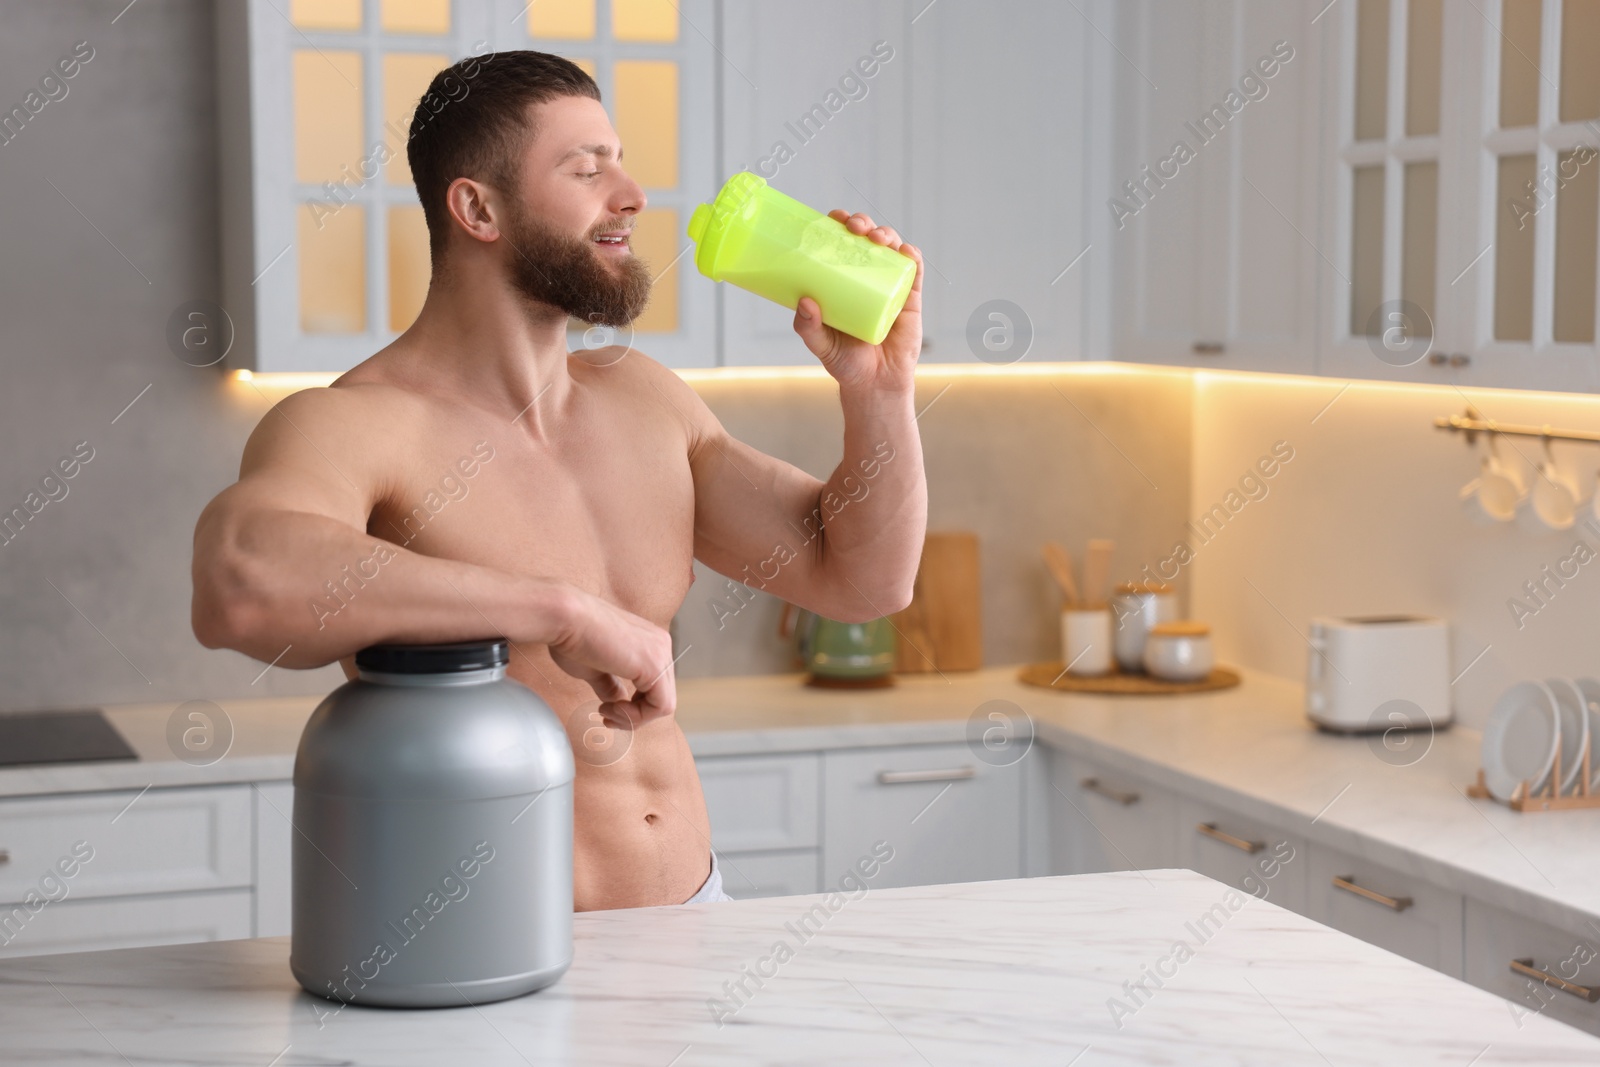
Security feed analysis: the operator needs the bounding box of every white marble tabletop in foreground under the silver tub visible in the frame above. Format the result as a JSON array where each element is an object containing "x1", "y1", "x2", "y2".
[{"x1": 0, "y1": 870, "x2": 1600, "y2": 1067}]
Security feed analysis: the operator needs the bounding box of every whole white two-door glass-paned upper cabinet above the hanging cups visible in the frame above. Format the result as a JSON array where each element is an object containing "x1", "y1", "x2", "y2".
[{"x1": 1318, "y1": 0, "x2": 1600, "y2": 390}]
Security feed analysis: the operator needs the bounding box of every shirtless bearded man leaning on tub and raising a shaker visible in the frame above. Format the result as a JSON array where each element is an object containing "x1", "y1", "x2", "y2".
[{"x1": 194, "y1": 51, "x2": 926, "y2": 910}]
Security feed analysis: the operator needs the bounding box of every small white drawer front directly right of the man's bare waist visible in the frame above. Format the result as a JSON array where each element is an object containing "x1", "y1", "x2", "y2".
[{"x1": 694, "y1": 752, "x2": 821, "y2": 854}]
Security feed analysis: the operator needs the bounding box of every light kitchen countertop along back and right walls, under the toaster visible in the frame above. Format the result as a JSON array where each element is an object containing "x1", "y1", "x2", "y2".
[{"x1": 12, "y1": 667, "x2": 1600, "y2": 929}]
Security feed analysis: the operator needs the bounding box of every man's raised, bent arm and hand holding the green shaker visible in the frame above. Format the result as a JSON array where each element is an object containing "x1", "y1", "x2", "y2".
[{"x1": 683, "y1": 211, "x2": 928, "y2": 622}]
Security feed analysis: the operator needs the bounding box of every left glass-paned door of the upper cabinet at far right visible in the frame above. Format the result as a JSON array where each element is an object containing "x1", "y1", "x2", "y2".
[{"x1": 1318, "y1": 0, "x2": 1478, "y2": 384}]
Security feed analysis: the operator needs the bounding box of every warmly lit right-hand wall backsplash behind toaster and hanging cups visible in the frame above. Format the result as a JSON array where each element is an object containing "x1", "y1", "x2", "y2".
[{"x1": 1182, "y1": 374, "x2": 1600, "y2": 726}]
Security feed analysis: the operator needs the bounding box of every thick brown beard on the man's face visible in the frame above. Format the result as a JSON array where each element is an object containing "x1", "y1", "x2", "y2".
[{"x1": 502, "y1": 199, "x2": 651, "y2": 326}]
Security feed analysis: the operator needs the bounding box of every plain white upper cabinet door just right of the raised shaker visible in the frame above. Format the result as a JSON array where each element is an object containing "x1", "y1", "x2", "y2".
[{"x1": 906, "y1": 0, "x2": 1110, "y2": 363}]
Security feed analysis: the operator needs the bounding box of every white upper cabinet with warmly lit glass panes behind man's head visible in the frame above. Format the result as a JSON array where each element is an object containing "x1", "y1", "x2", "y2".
[{"x1": 218, "y1": 0, "x2": 715, "y2": 371}]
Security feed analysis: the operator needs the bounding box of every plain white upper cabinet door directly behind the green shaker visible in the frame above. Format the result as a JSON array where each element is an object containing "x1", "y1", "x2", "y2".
[{"x1": 716, "y1": 0, "x2": 910, "y2": 366}]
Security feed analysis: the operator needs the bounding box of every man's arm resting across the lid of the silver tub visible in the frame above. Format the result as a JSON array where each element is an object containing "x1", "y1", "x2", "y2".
[{"x1": 190, "y1": 389, "x2": 675, "y2": 721}]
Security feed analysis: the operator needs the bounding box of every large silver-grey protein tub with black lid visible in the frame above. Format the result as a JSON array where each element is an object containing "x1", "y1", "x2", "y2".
[{"x1": 290, "y1": 638, "x2": 573, "y2": 1008}]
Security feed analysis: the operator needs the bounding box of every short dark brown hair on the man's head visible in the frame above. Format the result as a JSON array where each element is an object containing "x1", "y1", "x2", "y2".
[{"x1": 406, "y1": 50, "x2": 600, "y2": 270}]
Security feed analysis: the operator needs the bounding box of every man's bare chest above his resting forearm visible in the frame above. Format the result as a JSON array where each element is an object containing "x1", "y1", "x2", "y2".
[{"x1": 368, "y1": 426, "x2": 694, "y2": 625}]
